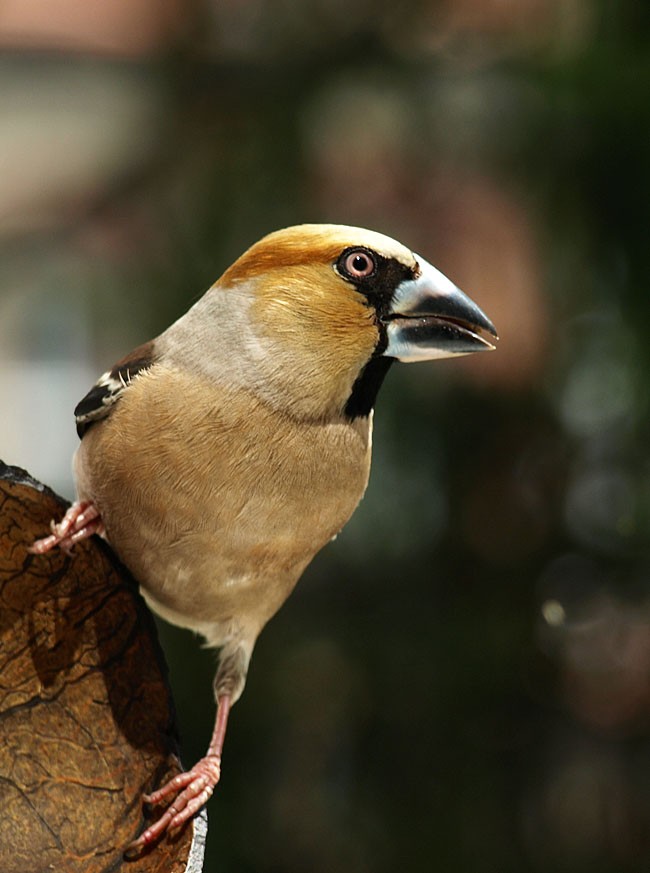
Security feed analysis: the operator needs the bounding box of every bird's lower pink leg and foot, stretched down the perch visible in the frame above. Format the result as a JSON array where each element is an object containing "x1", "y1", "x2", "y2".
[{"x1": 124, "y1": 695, "x2": 231, "y2": 859}]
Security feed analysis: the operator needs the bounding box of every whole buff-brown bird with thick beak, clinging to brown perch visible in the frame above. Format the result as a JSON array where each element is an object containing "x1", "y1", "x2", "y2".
[{"x1": 31, "y1": 224, "x2": 497, "y2": 856}]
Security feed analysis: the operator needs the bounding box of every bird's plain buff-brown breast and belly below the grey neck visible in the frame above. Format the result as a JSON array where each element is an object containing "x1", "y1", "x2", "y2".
[{"x1": 76, "y1": 367, "x2": 370, "y2": 630}]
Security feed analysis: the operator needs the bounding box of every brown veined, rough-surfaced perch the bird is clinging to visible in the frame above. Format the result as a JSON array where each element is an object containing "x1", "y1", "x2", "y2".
[{"x1": 0, "y1": 463, "x2": 202, "y2": 873}]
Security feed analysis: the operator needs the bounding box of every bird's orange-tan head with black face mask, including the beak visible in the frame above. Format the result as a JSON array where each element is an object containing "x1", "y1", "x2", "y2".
[{"x1": 167, "y1": 224, "x2": 496, "y2": 418}]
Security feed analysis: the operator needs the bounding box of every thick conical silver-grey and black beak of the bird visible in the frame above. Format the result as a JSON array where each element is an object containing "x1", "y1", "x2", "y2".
[{"x1": 384, "y1": 256, "x2": 498, "y2": 361}]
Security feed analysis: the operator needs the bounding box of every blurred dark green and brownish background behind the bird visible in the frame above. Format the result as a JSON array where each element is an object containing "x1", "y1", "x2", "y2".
[{"x1": 0, "y1": 0, "x2": 650, "y2": 873}]
